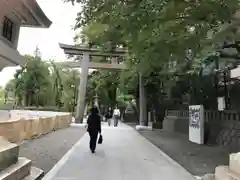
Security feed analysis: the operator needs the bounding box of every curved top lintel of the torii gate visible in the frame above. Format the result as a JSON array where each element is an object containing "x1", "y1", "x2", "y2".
[{"x1": 59, "y1": 43, "x2": 128, "y2": 57}]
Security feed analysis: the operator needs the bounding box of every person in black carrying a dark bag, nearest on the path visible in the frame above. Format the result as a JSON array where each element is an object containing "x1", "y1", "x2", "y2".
[{"x1": 87, "y1": 107, "x2": 101, "y2": 153}]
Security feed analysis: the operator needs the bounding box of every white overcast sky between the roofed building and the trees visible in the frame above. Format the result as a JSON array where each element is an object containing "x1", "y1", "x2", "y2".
[{"x1": 0, "y1": 0, "x2": 80, "y2": 87}]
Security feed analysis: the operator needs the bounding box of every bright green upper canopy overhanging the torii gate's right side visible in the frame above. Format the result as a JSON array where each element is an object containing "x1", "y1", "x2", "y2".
[{"x1": 68, "y1": 0, "x2": 239, "y2": 72}]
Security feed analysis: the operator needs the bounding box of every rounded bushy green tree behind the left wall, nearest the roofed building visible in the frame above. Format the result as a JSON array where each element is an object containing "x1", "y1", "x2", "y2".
[{"x1": 14, "y1": 55, "x2": 50, "y2": 106}]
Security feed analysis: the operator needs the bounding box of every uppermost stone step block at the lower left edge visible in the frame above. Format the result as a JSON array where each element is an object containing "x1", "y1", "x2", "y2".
[{"x1": 0, "y1": 137, "x2": 19, "y2": 172}]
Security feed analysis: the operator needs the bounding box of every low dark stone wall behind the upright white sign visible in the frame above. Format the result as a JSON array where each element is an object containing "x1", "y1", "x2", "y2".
[{"x1": 163, "y1": 111, "x2": 240, "y2": 152}]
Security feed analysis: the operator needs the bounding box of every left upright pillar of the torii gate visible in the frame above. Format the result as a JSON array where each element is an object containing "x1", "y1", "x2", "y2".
[{"x1": 75, "y1": 52, "x2": 90, "y2": 123}]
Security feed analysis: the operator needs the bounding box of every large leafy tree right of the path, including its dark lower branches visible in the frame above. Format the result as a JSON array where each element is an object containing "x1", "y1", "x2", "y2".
[{"x1": 65, "y1": 0, "x2": 239, "y2": 122}]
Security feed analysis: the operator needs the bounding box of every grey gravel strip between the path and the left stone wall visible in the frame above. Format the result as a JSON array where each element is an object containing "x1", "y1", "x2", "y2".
[{"x1": 20, "y1": 127, "x2": 86, "y2": 174}]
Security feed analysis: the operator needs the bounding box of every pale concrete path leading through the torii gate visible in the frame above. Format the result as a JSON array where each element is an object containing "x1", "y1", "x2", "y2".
[{"x1": 43, "y1": 124, "x2": 195, "y2": 180}]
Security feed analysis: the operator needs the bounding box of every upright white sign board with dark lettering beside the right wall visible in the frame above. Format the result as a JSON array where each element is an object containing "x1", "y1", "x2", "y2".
[{"x1": 189, "y1": 105, "x2": 204, "y2": 144}]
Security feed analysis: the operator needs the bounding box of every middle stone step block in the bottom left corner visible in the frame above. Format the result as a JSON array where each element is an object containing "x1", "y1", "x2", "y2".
[{"x1": 0, "y1": 158, "x2": 31, "y2": 180}]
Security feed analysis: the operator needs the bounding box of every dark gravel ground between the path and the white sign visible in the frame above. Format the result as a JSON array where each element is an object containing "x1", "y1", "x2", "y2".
[{"x1": 135, "y1": 130, "x2": 229, "y2": 176}]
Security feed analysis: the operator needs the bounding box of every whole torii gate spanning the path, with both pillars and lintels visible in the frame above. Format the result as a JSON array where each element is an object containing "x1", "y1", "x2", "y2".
[{"x1": 59, "y1": 44, "x2": 147, "y2": 126}]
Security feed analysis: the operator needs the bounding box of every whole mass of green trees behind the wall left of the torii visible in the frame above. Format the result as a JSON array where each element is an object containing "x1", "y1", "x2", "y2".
[{"x1": 4, "y1": 50, "x2": 80, "y2": 112}]
